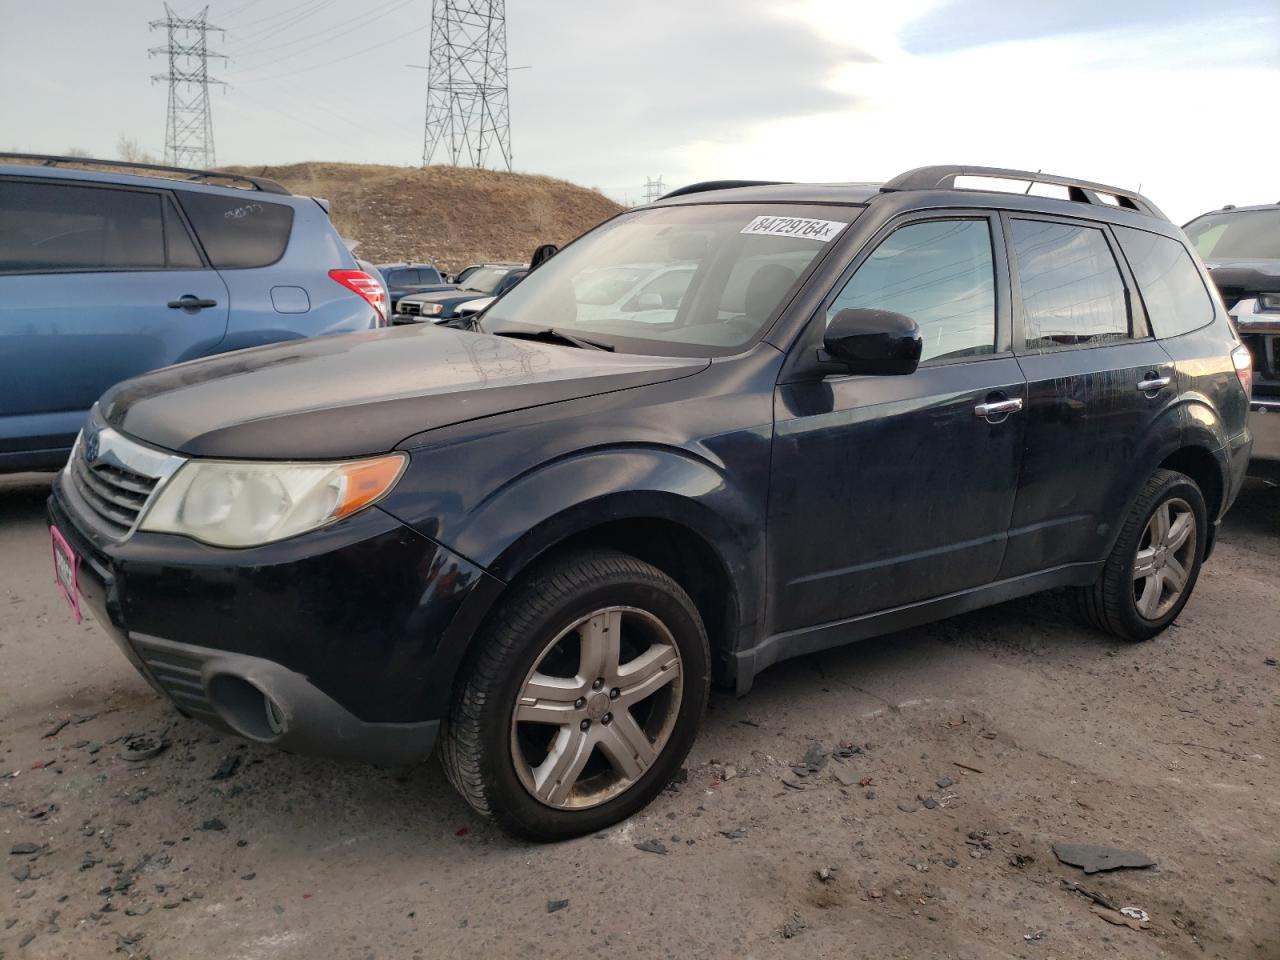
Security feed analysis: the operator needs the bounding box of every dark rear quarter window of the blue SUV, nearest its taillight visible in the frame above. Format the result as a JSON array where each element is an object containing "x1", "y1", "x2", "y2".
[{"x1": 179, "y1": 192, "x2": 293, "y2": 270}]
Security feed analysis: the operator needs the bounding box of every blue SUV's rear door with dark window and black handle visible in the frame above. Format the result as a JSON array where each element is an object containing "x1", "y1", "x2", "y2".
[{"x1": 0, "y1": 178, "x2": 228, "y2": 463}]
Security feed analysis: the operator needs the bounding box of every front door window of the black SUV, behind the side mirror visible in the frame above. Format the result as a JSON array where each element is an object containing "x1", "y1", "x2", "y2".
[{"x1": 827, "y1": 220, "x2": 996, "y2": 362}]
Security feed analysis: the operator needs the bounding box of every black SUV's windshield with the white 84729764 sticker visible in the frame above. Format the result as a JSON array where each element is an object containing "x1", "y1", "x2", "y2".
[{"x1": 468, "y1": 204, "x2": 860, "y2": 356}]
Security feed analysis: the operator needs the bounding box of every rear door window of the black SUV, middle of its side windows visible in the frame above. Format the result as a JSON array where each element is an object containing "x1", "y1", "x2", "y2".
[{"x1": 1012, "y1": 220, "x2": 1129, "y2": 349}]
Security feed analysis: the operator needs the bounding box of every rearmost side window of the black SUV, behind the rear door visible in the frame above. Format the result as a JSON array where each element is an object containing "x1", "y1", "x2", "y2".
[{"x1": 1112, "y1": 227, "x2": 1213, "y2": 337}]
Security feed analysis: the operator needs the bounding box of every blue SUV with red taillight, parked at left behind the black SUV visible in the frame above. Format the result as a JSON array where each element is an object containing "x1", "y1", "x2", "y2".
[{"x1": 0, "y1": 154, "x2": 387, "y2": 472}]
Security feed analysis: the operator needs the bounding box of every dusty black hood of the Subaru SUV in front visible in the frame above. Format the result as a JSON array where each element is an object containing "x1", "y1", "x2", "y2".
[{"x1": 99, "y1": 325, "x2": 710, "y2": 460}]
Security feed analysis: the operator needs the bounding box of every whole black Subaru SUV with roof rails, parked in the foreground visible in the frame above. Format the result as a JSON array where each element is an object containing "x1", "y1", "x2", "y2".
[{"x1": 49, "y1": 166, "x2": 1251, "y2": 840}]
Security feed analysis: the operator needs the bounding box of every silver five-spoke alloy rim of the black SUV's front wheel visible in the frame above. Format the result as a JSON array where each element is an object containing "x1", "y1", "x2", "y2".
[{"x1": 511, "y1": 607, "x2": 684, "y2": 809}]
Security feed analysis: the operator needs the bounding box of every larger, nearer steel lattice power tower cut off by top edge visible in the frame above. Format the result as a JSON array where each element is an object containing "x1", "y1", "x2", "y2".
[{"x1": 422, "y1": 0, "x2": 511, "y2": 170}]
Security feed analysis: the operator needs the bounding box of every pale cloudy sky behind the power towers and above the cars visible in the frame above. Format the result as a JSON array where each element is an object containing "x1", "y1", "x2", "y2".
[{"x1": 0, "y1": 0, "x2": 1280, "y2": 221}]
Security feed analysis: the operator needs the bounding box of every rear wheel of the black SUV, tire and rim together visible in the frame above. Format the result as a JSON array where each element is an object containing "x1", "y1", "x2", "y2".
[{"x1": 1075, "y1": 470, "x2": 1208, "y2": 641}]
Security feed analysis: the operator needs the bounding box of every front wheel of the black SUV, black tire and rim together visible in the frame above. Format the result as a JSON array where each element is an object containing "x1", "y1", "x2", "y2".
[{"x1": 442, "y1": 550, "x2": 710, "y2": 841}]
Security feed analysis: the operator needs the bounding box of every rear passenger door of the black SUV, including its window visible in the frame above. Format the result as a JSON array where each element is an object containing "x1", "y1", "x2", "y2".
[{"x1": 1001, "y1": 214, "x2": 1178, "y2": 579}]
